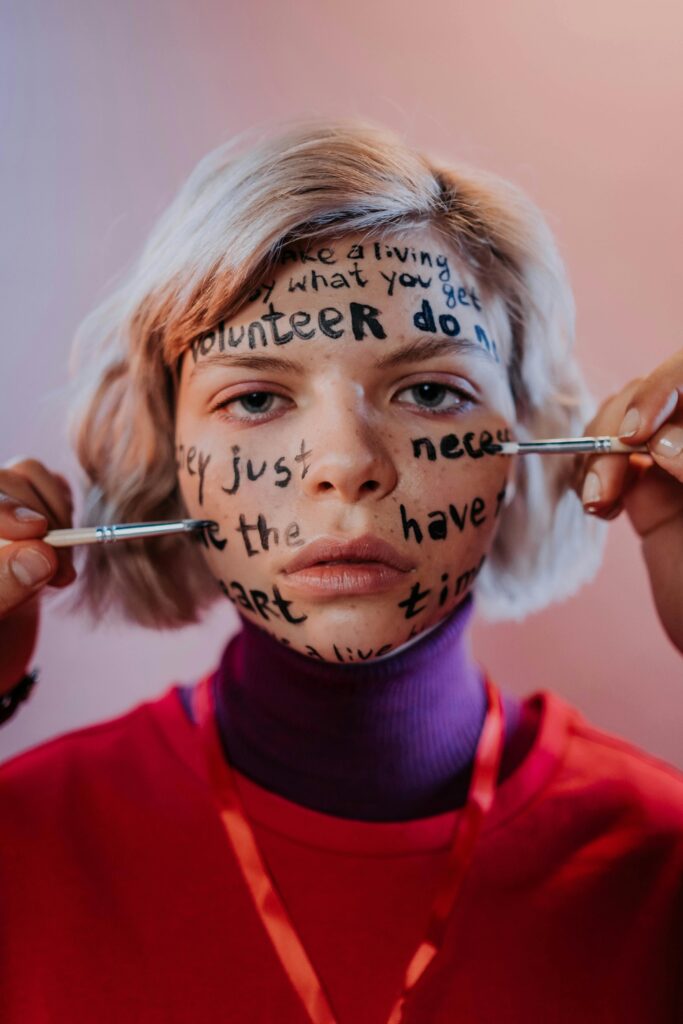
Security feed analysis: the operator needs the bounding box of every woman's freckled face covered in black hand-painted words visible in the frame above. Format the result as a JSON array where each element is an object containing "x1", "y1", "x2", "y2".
[{"x1": 175, "y1": 229, "x2": 514, "y2": 662}]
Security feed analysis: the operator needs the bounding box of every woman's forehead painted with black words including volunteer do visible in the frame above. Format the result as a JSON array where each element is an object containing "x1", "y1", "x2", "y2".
[{"x1": 183, "y1": 227, "x2": 508, "y2": 376}]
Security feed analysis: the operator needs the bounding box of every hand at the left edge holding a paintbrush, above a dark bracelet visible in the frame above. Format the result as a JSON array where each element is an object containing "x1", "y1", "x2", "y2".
[{"x1": 0, "y1": 458, "x2": 76, "y2": 693}]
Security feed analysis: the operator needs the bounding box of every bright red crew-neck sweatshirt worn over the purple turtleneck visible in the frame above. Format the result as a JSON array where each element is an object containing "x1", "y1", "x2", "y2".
[{"x1": 0, "y1": 687, "x2": 683, "y2": 1024}]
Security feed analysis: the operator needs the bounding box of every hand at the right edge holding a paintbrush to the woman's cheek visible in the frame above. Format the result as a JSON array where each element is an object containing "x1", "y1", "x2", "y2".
[{"x1": 577, "y1": 349, "x2": 683, "y2": 652}]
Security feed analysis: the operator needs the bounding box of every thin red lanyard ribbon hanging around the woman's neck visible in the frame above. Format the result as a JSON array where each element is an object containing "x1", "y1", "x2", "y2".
[{"x1": 194, "y1": 674, "x2": 504, "y2": 1024}]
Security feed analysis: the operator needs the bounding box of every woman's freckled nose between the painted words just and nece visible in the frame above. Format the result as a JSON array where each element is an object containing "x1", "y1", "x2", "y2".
[{"x1": 302, "y1": 393, "x2": 398, "y2": 504}]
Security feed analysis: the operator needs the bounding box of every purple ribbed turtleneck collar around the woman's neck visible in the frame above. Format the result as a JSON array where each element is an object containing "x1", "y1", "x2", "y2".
[{"x1": 181, "y1": 595, "x2": 533, "y2": 821}]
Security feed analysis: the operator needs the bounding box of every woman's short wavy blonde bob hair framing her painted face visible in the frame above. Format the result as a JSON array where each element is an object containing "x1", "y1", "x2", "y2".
[{"x1": 61, "y1": 118, "x2": 606, "y2": 629}]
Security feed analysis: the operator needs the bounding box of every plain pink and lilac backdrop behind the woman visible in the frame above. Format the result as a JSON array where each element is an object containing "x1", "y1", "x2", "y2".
[{"x1": 0, "y1": 0, "x2": 683, "y2": 767}]
